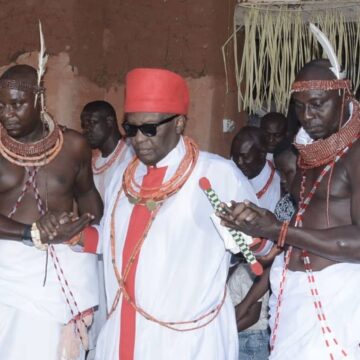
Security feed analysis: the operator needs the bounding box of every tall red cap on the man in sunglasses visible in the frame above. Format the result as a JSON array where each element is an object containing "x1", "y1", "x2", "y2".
[{"x1": 124, "y1": 69, "x2": 189, "y2": 115}]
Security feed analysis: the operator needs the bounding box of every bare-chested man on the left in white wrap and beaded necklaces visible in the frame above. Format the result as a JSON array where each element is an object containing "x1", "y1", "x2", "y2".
[{"x1": 0, "y1": 65, "x2": 102, "y2": 360}]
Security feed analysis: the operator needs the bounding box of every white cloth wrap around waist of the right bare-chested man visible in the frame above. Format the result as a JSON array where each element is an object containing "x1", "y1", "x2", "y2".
[{"x1": 269, "y1": 254, "x2": 360, "y2": 360}]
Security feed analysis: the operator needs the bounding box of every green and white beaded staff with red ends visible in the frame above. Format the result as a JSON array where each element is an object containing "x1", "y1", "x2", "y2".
[{"x1": 199, "y1": 177, "x2": 263, "y2": 275}]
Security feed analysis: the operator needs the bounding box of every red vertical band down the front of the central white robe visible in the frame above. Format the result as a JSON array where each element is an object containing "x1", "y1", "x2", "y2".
[{"x1": 119, "y1": 167, "x2": 167, "y2": 360}]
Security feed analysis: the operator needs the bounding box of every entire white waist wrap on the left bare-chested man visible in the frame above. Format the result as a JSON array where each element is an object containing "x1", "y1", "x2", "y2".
[{"x1": 0, "y1": 240, "x2": 98, "y2": 360}]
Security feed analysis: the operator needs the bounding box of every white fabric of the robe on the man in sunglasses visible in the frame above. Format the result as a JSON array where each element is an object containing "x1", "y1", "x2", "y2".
[{"x1": 96, "y1": 139, "x2": 257, "y2": 360}]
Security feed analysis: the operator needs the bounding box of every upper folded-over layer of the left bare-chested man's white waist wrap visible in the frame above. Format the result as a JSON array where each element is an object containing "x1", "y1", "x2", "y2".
[{"x1": 0, "y1": 240, "x2": 98, "y2": 324}]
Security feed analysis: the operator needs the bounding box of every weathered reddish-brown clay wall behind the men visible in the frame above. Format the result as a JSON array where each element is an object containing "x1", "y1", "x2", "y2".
[{"x1": 0, "y1": 0, "x2": 245, "y2": 155}]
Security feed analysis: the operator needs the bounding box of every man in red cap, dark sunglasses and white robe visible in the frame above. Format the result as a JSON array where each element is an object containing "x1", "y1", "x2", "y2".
[{"x1": 85, "y1": 69, "x2": 256, "y2": 360}]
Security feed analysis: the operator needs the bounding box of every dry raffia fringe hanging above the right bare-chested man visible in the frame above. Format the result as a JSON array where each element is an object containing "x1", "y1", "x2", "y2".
[{"x1": 225, "y1": 1, "x2": 360, "y2": 113}]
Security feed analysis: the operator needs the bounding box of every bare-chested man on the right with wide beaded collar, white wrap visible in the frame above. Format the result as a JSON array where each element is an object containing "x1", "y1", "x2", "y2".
[{"x1": 224, "y1": 60, "x2": 360, "y2": 360}]
